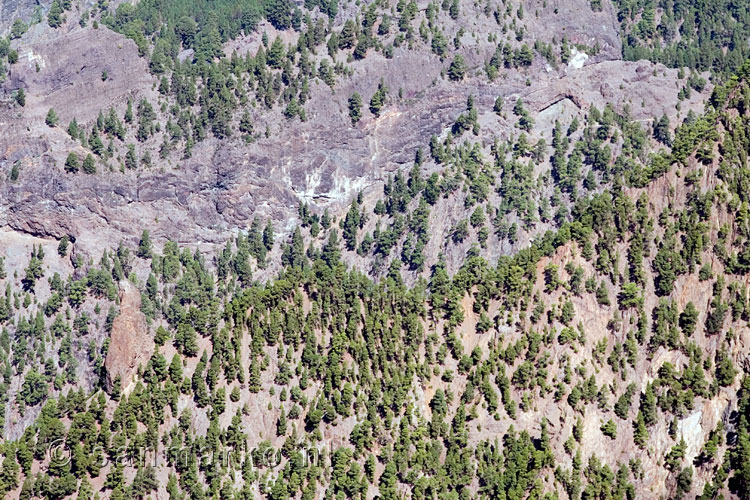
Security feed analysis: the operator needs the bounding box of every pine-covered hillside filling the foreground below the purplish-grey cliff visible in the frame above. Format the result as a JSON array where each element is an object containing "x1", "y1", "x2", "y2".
[{"x1": 0, "y1": 42, "x2": 750, "y2": 499}]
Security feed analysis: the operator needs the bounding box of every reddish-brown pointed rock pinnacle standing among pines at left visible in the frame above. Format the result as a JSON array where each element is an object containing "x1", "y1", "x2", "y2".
[{"x1": 104, "y1": 281, "x2": 154, "y2": 394}]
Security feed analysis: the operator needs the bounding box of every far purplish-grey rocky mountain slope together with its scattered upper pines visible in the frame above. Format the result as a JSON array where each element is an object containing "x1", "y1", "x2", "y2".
[{"x1": 0, "y1": 1, "x2": 710, "y2": 274}]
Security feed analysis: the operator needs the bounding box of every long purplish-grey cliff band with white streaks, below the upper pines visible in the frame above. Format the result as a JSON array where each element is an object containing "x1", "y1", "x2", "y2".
[{"x1": 0, "y1": 58, "x2": 700, "y2": 255}]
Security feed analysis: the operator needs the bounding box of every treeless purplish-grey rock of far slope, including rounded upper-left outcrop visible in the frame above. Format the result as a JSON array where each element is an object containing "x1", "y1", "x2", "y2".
[{"x1": 0, "y1": 0, "x2": 712, "y2": 270}]
